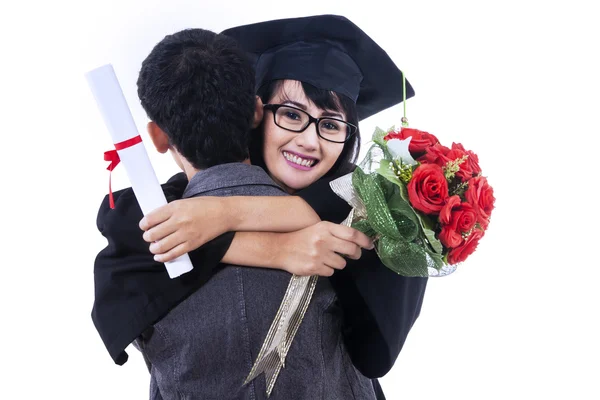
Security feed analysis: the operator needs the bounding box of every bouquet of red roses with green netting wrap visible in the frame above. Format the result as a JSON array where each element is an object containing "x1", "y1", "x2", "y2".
[{"x1": 331, "y1": 127, "x2": 495, "y2": 276}]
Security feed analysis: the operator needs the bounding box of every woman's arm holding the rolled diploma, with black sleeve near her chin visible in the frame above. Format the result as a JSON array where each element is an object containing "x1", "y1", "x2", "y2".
[{"x1": 140, "y1": 174, "x2": 350, "y2": 267}]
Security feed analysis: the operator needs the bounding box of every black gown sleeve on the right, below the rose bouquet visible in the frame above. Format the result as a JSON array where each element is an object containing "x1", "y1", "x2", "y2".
[{"x1": 297, "y1": 172, "x2": 427, "y2": 378}]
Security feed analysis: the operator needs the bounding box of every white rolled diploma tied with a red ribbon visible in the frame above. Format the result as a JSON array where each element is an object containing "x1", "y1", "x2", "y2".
[{"x1": 85, "y1": 64, "x2": 193, "y2": 278}]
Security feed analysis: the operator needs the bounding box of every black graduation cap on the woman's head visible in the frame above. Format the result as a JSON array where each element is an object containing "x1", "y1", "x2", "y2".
[{"x1": 221, "y1": 15, "x2": 415, "y2": 120}]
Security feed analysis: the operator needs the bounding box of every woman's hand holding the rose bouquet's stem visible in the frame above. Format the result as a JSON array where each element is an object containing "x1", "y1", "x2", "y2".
[{"x1": 276, "y1": 221, "x2": 373, "y2": 276}]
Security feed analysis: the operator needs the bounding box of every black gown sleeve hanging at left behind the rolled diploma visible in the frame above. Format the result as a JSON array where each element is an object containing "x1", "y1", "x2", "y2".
[{"x1": 92, "y1": 174, "x2": 234, "y2": 365}]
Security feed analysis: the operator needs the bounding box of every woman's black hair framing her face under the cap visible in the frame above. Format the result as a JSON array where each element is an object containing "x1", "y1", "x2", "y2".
[{"x1": 250, "y1": 80, "x2": 360, "y2": 177}]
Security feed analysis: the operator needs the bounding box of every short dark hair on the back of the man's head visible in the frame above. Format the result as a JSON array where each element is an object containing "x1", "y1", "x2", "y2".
[{"x1": 137, "y1": 29, "x2": 256, "y2": 169}]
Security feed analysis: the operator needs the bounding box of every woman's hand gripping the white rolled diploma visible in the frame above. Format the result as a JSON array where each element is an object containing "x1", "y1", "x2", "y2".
[{"x1": 140, "y1": 197, "x2": 232, "y2": 262}]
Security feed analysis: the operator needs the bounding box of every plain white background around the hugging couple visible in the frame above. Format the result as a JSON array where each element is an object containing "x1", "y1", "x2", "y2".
[{"x1": 0, "y1": 0, "x2": 600, "y2": 400}]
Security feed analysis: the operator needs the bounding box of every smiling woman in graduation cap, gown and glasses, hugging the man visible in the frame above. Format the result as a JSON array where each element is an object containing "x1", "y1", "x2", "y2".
[{"x1": 140, "y1": 17, "x2": 426, "y2": 396}]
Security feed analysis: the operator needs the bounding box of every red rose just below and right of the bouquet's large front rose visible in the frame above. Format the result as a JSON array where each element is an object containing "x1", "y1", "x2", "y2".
[{"x1": 439, "y1": 196, "x2": 477, "y2": 249}]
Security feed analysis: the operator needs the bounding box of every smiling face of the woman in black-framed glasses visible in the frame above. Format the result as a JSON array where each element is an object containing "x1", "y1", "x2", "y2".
[{"x1": 263, "y1": 80, "x2": 346, "y2": 193}]
